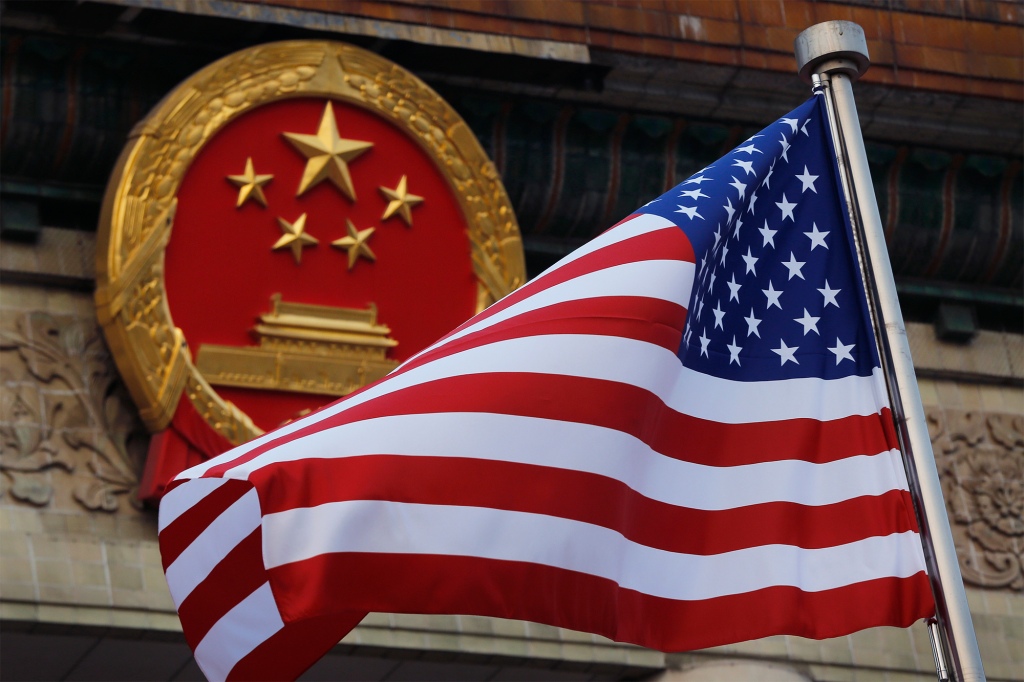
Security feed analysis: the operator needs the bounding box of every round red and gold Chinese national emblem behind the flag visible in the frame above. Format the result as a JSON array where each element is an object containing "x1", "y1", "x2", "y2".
[{"x1": 96, "y1": 41, "x2": 525, "y2": 497}]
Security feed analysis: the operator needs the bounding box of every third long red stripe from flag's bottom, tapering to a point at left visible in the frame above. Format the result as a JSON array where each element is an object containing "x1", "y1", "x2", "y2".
[{"x1": 205, "y1": 366, "x2": 896, "y2": 476}]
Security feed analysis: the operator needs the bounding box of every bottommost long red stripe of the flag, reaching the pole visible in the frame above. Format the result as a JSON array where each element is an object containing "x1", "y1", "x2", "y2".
[{"x1": 269, "y1": 553, "x2": 935, "y2": 651}]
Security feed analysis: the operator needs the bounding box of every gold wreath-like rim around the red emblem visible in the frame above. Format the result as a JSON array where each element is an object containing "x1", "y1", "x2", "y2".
[{"x1": 95, "y1": 41, "x2": 525, "y2": 443}]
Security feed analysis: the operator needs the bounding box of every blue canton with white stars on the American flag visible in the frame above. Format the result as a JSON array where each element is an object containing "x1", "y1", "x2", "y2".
[{"x1": 641, "y1": 96, "x2": 879, "y2": 381}]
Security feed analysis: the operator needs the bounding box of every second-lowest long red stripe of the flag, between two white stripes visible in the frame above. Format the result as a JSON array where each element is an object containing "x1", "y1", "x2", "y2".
[{"x1": 250, "y1": 455, "x2": 916, "y2": 555}]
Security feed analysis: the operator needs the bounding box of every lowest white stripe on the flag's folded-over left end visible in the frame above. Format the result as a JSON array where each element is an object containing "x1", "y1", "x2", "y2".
[{"x1": 196, "y1": 583, "x2": 285, "y2": 682}]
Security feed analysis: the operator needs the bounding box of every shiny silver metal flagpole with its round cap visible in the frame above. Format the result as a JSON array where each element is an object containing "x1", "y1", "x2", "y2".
[{"x1": 795, "y1": 22, "x2": 985, "y2": 682}]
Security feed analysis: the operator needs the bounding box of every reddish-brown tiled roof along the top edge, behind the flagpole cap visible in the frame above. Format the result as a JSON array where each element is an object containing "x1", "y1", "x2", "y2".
[{"x1": 246, "y1": 0, "x2": 1024, "y2": 101}]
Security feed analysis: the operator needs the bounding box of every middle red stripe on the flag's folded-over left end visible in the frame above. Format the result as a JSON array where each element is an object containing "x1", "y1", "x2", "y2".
[{"x1": 178, "y1": 528, "x2": 267, "y2": 650}]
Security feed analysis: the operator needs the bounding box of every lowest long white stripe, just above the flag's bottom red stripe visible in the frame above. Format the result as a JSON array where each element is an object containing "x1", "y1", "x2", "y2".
[{"x1": 263, "y1": 500, "x2": 925, "y2": 600}]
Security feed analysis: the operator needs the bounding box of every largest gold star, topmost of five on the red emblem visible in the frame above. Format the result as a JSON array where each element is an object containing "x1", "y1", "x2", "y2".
[{"x1": 282, "y1": 102, "x2": 374, "y2": 202}]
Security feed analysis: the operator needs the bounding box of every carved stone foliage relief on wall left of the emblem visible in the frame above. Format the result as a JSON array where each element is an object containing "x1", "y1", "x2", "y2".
[{"x1": 0, "y1": 311, "x2": 146, "y2": 512}]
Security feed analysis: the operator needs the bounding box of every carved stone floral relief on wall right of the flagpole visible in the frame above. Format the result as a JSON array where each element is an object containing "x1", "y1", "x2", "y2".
[{"x1": 928, "y1": 403, "x2": 1024, "y2": 590}]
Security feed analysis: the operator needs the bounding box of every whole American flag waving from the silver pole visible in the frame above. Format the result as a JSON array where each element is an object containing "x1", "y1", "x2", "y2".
[{"x1": 160, "y1": 97, "x2": 934, "y2": 679}]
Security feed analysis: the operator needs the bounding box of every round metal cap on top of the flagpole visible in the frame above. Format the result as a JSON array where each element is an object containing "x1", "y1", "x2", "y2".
[{"x1": 793, "y1": 20, "x2": 871, "y2": 83}]
